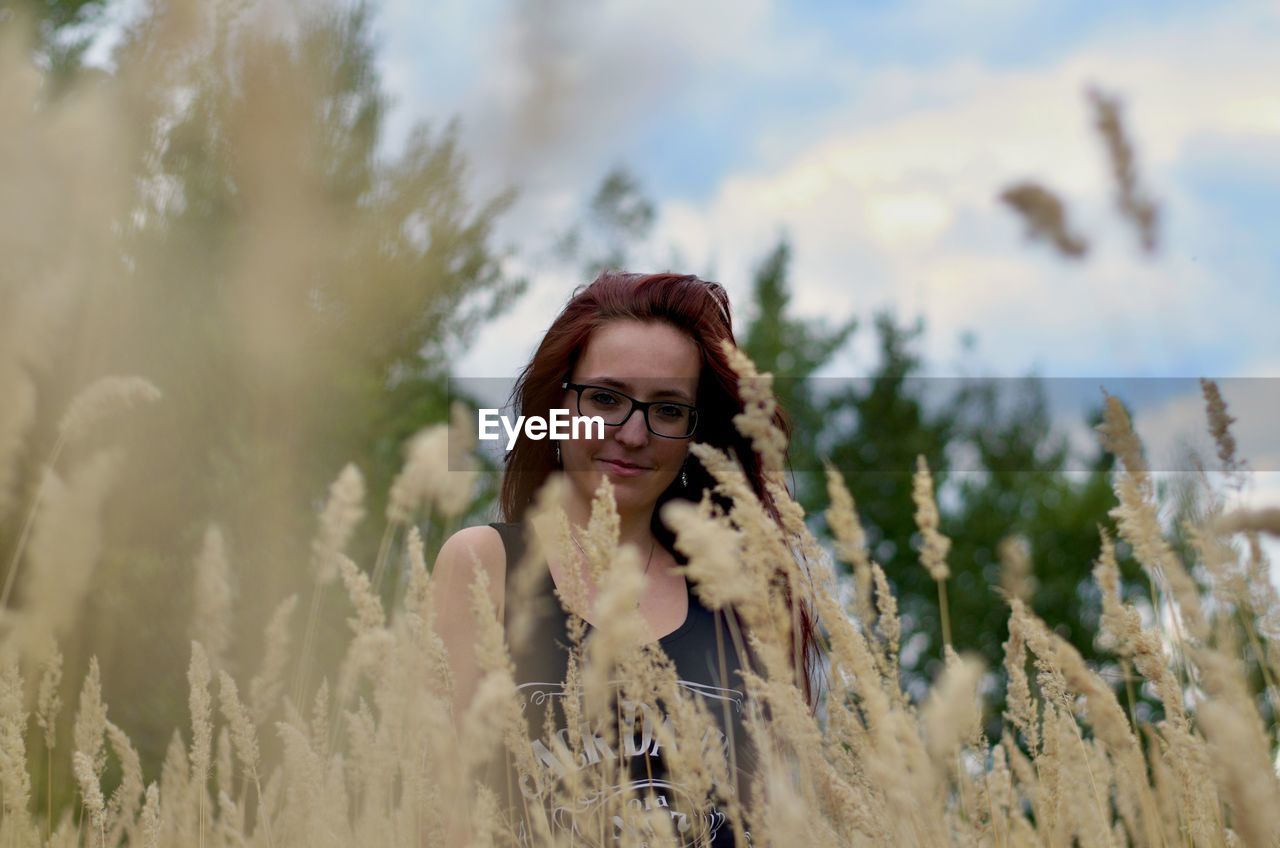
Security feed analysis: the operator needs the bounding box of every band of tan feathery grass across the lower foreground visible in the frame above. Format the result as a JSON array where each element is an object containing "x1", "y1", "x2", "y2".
[{"x1": 0, "y1": 335, "x2": 1280, "y2": 848}]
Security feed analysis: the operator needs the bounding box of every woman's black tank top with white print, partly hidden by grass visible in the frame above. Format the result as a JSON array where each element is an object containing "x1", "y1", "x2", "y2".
[{"x1": 489, "y1": 524, "x2": 755, "y2": 848}]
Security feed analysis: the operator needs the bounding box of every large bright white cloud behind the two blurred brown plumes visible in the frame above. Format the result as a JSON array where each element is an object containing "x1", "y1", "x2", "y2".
[{"x1": 650, "y1": 4, "x2": 1280, "y2": 374}]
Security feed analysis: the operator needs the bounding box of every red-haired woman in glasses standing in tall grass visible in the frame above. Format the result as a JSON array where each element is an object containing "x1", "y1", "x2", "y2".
[{"x1": 433, "y1": 272, "x2": 814, "y2": 845}]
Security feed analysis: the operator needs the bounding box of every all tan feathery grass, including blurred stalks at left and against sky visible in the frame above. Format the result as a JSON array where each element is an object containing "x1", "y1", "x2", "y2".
[{"x1": 0, "y1": 4, "x2": 1280, "y2": 848}]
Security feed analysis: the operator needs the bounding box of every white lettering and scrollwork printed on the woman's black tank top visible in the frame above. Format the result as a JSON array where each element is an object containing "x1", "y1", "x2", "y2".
[{"x1": 506, "y1": 680, "x2": 750, "y2": 845}]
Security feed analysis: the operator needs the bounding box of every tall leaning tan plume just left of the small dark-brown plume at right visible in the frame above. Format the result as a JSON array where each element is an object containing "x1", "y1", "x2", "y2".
[{"x1": 1096, "y1": 395, "x2": 1208, "y2": 639}]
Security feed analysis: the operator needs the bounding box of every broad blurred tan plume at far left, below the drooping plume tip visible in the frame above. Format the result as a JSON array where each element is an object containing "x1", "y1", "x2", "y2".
[{"x1": 6, "y1": 452, "x2": 120, "y2": 656}]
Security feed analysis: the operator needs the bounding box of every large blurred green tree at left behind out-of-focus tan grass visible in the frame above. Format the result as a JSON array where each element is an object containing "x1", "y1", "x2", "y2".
[{"x1": 0, "y1": 3, "x2": 524, "y2": 804}]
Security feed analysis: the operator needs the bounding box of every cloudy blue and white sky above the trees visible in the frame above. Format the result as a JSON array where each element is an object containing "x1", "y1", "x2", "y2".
[{"x1": 378, "y1": 0, "x2": 1280, "y2": 502}]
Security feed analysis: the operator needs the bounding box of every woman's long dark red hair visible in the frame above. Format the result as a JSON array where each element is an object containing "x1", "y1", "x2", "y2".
[{"x1": 499, "y1": 270, "x2": 817, "y2": 705}]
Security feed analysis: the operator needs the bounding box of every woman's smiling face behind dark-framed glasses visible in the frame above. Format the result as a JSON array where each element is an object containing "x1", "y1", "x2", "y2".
[{"x1": 559, "y1": 319, "x2": 703, "y2": 512}]
